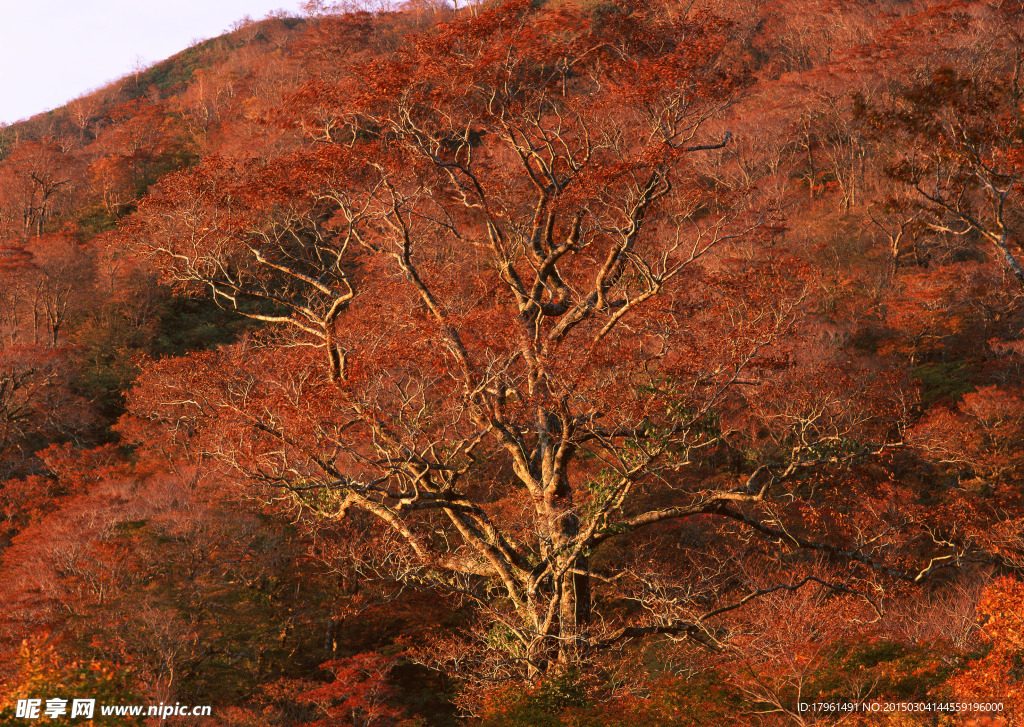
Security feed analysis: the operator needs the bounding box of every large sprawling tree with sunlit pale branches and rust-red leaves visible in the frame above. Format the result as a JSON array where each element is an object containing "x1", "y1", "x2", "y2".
[{"x1": 126, "y1": 0, "x2": 959, "y2": 679}]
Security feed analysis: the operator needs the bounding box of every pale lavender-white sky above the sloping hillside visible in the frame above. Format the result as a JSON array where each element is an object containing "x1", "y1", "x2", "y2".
[{"x1": 0, "y1": 0, "x2": 301, "y2": 124}]
